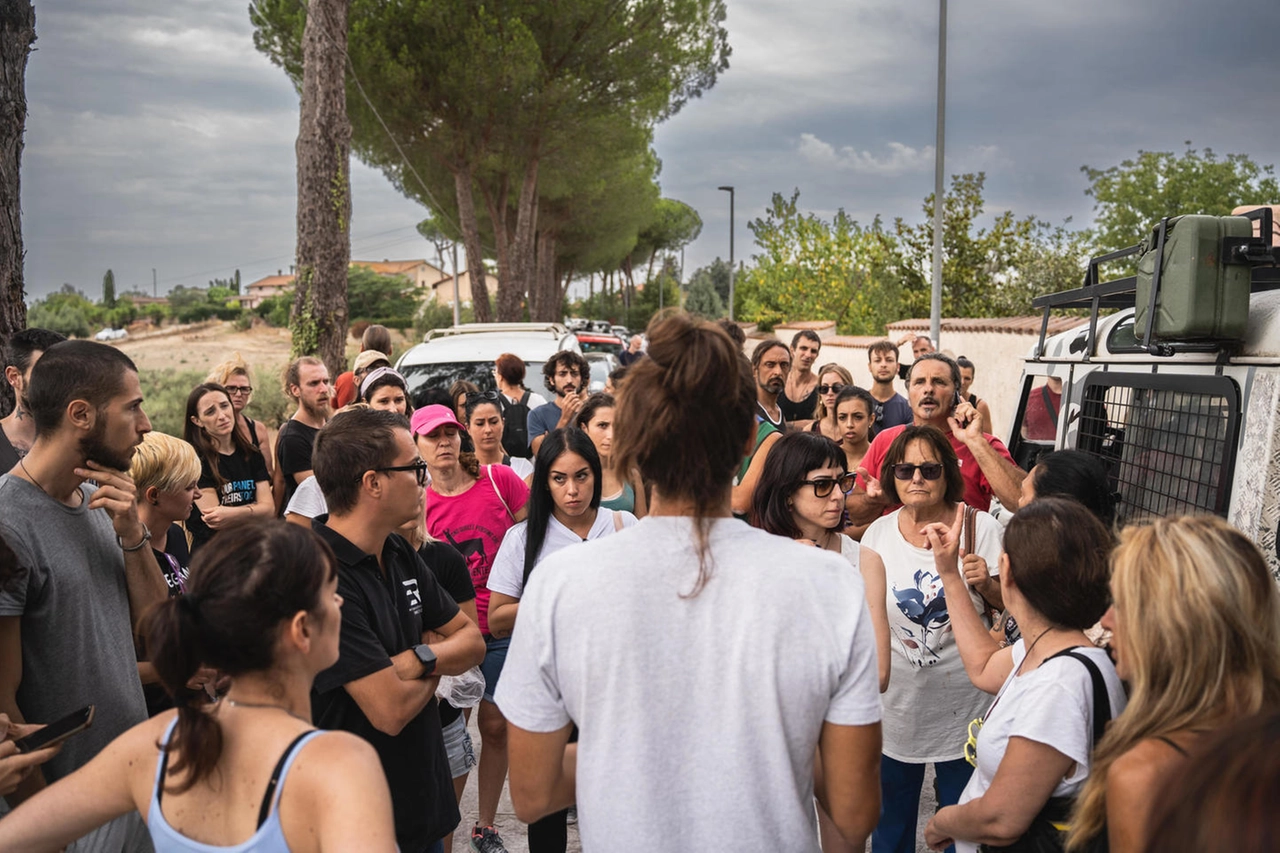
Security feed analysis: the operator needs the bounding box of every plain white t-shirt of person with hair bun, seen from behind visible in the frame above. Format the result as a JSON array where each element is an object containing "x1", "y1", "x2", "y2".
[{"x1": 497, "y1": 516, "x2": 881, "y2": 853}]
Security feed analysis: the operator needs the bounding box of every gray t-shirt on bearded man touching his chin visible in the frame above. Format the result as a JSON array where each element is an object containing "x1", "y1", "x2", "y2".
[{"x1": 0, "y1": 474, "x2": 147, "y2": 781}]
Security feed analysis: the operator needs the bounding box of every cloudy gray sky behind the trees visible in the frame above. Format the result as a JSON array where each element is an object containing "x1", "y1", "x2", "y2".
[{"x1": 22, "y1": 0, "x2": 1280, "y2": 298}]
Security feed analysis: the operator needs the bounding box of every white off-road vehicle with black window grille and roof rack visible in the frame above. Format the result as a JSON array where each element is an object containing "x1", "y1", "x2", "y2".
[{"x1": 1007, "y1": 210, "x2": 1280, "y2": 580}]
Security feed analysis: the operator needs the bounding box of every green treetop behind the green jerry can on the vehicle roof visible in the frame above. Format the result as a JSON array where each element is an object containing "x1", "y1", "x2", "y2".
[{"x1": 1080, "y1": 142, "x2": 1280, "y2": 254}]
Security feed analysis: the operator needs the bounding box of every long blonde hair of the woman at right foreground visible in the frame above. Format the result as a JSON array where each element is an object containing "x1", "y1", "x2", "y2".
[{"x1": 1069, "y1": 516, "x2": 1280, "y2": 849}]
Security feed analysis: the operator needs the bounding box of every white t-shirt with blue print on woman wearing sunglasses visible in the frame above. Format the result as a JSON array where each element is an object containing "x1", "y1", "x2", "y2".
[{"x1": 863, "y1": 510, "x2": 1004, "y2": 763}]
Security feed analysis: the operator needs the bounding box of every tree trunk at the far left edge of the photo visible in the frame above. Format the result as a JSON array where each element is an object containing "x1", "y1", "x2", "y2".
[{"x1": 0, "y1": 0, "x2": 36, "y2": 415}]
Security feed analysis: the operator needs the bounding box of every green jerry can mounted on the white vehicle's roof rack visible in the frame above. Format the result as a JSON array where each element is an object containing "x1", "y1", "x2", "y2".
[{"x1": 1133, "y1": 215, "x2": 1253, "y2": 341}]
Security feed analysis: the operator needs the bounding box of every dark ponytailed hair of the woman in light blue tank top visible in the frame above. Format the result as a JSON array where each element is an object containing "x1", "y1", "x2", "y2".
[{"x1": 143, "y1": 519, "x2": 338, "y2": 794}]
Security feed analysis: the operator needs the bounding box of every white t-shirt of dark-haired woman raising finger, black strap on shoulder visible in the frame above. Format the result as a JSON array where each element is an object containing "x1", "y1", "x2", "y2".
[{"x1": 956, "y1": 640, "x2": 1128, "y2": 853}]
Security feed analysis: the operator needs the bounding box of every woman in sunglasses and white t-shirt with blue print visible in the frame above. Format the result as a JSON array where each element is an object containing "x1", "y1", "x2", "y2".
[{"x1": 863, "y1": 425, "x2": 1001, "y2": 853}]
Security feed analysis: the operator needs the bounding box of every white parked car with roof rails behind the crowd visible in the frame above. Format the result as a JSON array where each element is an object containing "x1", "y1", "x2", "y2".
[{"x1": 396, "y1": 323, "x2": 582, "y2": 407}]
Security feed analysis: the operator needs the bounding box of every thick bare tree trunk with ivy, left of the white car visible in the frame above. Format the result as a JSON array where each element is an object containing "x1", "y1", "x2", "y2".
[{"x1": 292, "y1": 0, "x2": 351, "y2": 377}]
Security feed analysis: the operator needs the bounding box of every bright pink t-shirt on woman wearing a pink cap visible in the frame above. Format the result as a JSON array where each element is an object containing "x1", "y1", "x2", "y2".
[{"x1": 426, "y1": 465, "x2": 529, "y2": 634}]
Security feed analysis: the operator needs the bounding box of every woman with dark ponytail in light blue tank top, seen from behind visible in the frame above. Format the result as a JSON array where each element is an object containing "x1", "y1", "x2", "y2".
[{"x1": 0, "y1": 519, "x2": 396, "y2": 853}]
